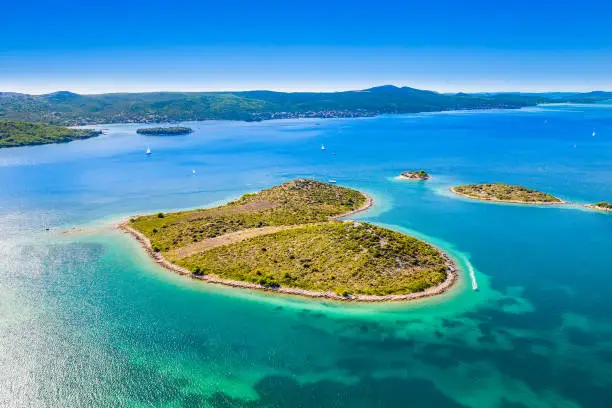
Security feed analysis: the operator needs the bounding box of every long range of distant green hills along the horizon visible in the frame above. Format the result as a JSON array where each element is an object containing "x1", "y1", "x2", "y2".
[{"x1": 0, "y1": 85, "x2": 612, "y2": 125}]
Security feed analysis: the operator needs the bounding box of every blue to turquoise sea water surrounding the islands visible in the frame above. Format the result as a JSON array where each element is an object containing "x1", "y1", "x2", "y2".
[{"x1": 0, "y1": 105, "x2": 612, "y2": 408}]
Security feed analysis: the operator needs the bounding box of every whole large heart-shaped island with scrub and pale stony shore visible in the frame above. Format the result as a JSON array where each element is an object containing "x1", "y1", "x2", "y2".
[{"x1": 120, "y1": 179, "x2": 456, "y2": 301}]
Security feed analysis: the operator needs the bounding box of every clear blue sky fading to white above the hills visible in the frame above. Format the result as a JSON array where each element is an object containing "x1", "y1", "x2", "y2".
[{"x1": 0, "y1": 0, "x2": 612, "y2": 93}]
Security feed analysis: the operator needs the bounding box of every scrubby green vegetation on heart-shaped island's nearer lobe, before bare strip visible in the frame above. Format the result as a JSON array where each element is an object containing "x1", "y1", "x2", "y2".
[{"x1": 173, "y1": 221, "x2": 448, "y2": 296}]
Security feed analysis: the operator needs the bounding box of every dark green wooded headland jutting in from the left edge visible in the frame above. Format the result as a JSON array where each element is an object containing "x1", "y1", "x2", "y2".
[{"x1": 0, "y1": 120, "x2": 102, "y2": 148}]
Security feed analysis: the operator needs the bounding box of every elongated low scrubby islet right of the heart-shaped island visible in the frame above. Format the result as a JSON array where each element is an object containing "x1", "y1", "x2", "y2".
[{"x1": 451, "y1": 183, "x2": 563, "y2": 204}]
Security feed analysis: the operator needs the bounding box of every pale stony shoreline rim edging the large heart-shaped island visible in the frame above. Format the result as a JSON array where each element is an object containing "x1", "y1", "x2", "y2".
[{"x1": 116, "y1": 193, "x2": 458, "y2": 302}]
